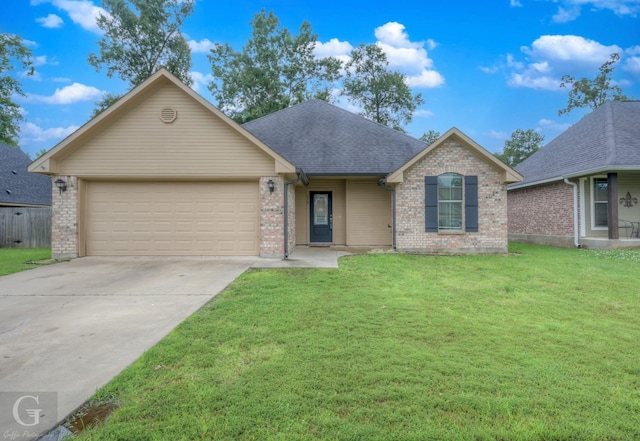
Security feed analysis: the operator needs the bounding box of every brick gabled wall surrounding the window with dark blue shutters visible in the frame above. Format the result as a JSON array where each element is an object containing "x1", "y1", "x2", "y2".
[{"x1": 396, "y1": 140, "x2": 508, "y2": 254}]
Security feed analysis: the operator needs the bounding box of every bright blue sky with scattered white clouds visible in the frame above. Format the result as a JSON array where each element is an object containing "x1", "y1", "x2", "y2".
[{"x1": 0, "y1": 0, "x2": 640, "y2": 158}]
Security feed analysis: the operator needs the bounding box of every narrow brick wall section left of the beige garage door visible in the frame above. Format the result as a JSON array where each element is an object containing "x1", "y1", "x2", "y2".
[{"x1": 51, "y1": 176, "x2": 78, "y2": 259}]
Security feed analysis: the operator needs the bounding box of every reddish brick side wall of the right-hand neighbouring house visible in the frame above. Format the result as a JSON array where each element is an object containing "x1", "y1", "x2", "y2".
[{"x1": 507, "y1": 181, "x2": 578, "y2": 247}]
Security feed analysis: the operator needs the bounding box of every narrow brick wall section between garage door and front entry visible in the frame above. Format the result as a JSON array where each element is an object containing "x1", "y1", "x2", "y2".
[{"x1": 260, "y1": 176, "x2": 284, "y2": 258}]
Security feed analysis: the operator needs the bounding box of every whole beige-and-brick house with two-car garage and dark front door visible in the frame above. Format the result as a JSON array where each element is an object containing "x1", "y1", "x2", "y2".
[{"x1": 30, "y1": 69, "x2": 521, "y2": 257}]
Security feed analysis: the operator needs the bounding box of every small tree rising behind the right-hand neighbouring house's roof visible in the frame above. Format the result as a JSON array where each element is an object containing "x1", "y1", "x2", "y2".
[{"x1": 558, "y1": 54, "x2": 627, "y2": 115}]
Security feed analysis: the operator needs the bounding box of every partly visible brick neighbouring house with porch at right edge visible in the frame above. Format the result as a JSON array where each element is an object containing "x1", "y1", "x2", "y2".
[{"x1": 509, "y1": 101, "x2": 640, "y2": 248}]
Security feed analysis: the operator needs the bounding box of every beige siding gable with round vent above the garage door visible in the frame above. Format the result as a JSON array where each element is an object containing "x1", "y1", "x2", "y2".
[{"x1": 59, "y1": 82, "x2": 278, "y2": 179}]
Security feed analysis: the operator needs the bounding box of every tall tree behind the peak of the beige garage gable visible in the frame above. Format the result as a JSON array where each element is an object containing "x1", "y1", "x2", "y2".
[{"x1": 88, "y1": 0, "x2": 195, "y2": 111}]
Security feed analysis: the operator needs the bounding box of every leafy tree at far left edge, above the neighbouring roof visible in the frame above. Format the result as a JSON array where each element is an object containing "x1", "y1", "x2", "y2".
[{"x1": 0, "y1": 33, "x2": 34, "y2": 146}]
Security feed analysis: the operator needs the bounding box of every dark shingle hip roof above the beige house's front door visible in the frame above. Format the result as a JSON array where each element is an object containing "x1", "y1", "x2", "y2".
[{"x1": 243, "y1": 100, "x2": 427, "y2": 176}]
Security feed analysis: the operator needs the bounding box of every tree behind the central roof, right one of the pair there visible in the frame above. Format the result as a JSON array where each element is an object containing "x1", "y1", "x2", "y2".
[{"x1": 342, "y1": 44, "x2": 424, "y2": 131}]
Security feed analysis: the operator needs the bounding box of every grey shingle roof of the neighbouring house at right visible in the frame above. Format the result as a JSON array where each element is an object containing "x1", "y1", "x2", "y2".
[{"x1": 509, "y1": 101, "x2": 640, "y2": 188}]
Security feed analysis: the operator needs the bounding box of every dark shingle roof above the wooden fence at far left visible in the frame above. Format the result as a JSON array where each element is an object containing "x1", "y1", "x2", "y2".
[{"x1": 0, "y1": 144, "x2": 51, "y2": 205}]
